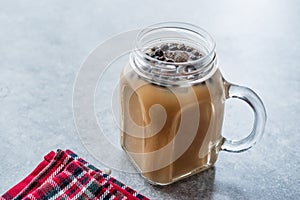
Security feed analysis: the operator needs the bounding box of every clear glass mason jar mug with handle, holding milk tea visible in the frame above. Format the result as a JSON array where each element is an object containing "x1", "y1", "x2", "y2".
[{"x1": 120, "y1": 23, "x2": 266, "y2": 185}]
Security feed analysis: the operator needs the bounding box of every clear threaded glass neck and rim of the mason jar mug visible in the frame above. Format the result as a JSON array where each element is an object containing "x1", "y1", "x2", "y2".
[{"x1": 130, "y1": 22, "x2": 217, "y2": 86}]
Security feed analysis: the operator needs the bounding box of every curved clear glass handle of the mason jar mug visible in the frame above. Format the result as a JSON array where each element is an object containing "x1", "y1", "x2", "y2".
[{"x1": 221, "y1": 82, "x2": 267, "y2": 153}]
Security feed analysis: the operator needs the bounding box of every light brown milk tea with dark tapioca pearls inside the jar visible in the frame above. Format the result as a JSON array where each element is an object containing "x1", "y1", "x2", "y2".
[{"x1": 120, "y1": 44, "x2": 225, "y2": 185}]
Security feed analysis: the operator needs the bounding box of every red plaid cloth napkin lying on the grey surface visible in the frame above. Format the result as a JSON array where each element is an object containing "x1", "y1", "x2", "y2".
[{"x1": 0, "y1": 150, "x2": 148, "y2": 200}]
